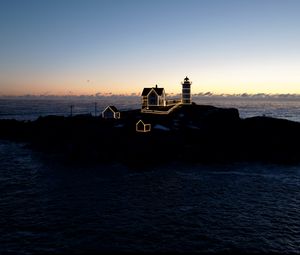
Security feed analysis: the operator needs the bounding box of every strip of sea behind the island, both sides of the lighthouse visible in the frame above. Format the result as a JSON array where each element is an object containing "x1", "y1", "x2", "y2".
[{"x1": 0, "y1": 96, "x2": 300, "y2": 122}]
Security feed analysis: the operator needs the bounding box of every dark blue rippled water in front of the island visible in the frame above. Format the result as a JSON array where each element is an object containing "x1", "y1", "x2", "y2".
[{"x1": 0, "y1": 141, "x2": 300, "y2": 254}]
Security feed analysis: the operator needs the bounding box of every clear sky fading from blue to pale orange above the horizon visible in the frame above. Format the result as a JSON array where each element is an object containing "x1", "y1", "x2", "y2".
[{"x1": 0, "y1": 0, "x2": 300, "y2": 95}]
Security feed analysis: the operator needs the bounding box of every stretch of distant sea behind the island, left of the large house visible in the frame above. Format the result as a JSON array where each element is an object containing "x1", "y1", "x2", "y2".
[{"x1": 0, "y1": 96, "x2": 140, "y2": 120}]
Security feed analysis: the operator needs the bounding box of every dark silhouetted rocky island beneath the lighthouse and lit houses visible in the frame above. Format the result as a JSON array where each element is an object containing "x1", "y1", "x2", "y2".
[{"x1": 0, "y1": 103, "x2": 300, "y2": 166}]
